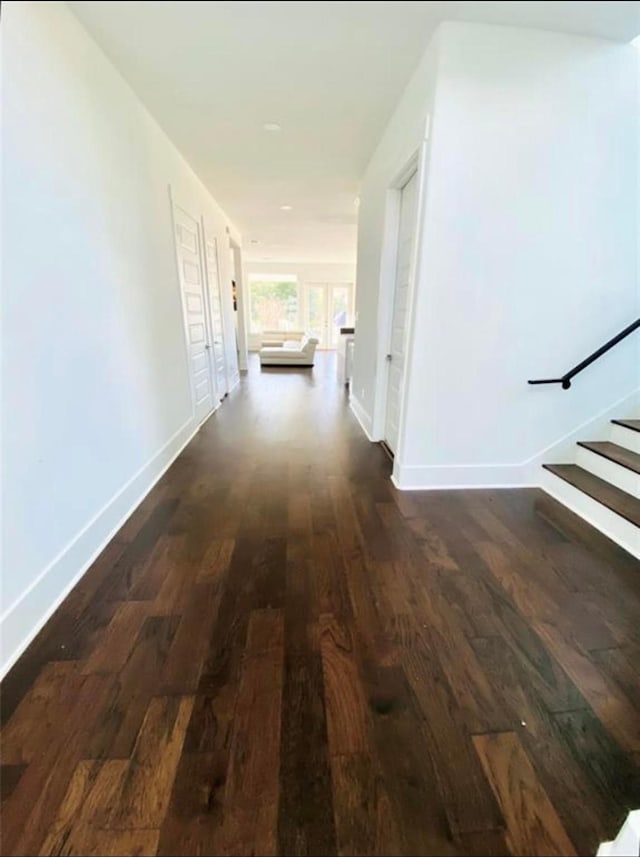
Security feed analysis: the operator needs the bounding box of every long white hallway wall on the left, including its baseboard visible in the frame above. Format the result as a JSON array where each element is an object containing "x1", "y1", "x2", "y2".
[{"x1": 1, "y1": 2, "x2": 241, "y2": 669}]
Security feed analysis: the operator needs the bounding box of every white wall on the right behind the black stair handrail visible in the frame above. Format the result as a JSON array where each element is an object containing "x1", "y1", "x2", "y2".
[{"x1": 354, "y1": 23, "x2": 640, "y2": 487}]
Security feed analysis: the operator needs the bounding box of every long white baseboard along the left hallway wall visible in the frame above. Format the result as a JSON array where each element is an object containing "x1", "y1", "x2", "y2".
[{"x1": 0, "y1": 418, "x2": 201, "y2": 677}]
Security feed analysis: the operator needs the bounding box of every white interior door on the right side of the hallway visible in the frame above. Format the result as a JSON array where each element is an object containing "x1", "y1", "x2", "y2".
[{"x1": 384, "y1": 173, "x2": 418, "y2": 453}]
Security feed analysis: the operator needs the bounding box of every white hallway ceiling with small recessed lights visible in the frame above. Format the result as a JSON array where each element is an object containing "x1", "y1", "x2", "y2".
[{"x1": 69, "y1": 0, "x2": 640, "y2": 262}]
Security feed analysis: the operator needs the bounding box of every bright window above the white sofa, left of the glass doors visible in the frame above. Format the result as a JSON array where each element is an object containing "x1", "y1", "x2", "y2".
[{"x1": 249, "y1": 274, "x2": 301, "y2": 333}]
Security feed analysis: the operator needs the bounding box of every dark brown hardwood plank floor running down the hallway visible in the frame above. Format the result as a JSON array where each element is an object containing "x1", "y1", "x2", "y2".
[{"x1": 0, "y1": 355, "x2": 640, "y2": 855}]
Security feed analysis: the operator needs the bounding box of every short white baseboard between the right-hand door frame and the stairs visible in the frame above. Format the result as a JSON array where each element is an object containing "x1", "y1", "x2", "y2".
[{"x1": 391, "y1": 460, "x2": 537, "y2": 491}]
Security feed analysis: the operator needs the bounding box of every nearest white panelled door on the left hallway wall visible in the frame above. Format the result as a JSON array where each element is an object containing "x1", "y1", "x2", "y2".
[{"x1": 173, "y1": 206, "x2": 214, "y2": 423}]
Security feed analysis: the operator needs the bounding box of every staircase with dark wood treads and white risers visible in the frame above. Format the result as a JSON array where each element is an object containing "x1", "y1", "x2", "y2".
[{"x1": 542, "y1": 419, "x2": 640, "y2": 559}]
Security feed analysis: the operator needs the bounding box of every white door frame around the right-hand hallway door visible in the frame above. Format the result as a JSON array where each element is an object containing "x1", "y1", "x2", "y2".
[{"x1": 372, "y1": 142, "x2": 428, "y2": 468}]
